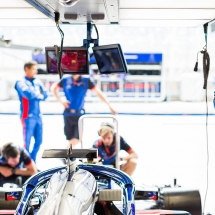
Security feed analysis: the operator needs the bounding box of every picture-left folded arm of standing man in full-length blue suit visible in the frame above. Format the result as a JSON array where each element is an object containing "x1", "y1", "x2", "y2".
[{"x1": 15, "y1": 82, "x2": 44, "y2": 100}]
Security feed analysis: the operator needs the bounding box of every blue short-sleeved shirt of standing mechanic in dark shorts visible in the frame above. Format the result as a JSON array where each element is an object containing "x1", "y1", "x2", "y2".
[{"x1": 58, "y1": 76, "x2": 95, "y2": 110}]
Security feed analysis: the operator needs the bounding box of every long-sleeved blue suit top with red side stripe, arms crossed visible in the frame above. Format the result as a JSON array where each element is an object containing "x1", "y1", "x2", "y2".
[{"x1": 15, "y1": 77, "x2": 48, "y2": 119}]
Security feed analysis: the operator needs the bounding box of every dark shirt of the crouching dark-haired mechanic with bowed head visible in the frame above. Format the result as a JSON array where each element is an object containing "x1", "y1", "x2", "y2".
[{"x1": 0, "y1": 147, "x2": 32, "y2": 169}]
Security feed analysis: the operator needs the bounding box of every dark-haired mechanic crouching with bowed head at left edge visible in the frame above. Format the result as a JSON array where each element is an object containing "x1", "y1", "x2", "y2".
[{"x1": 0, "y1": 143, "x2": 37, "y2": 187}]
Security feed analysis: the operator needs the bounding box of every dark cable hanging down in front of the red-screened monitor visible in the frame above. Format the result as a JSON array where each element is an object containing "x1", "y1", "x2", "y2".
[{"x1": 55, "y1": 12, "x2": 64, "y2": 79}]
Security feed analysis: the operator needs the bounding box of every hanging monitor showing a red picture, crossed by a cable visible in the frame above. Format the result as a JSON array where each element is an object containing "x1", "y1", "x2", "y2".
[{"x1": 45, "y1": 47, "x2": 89, "y2": 75}]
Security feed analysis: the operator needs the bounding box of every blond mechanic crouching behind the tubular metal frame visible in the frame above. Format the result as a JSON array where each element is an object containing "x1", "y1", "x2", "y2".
[{"x1": 93, "y1": 122, "x2": 138, "y2": 176}]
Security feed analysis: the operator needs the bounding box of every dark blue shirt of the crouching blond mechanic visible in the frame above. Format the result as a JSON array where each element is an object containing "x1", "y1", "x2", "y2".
[{"x1": 93, "y1": 134, "x2": 132, "y2": 165}]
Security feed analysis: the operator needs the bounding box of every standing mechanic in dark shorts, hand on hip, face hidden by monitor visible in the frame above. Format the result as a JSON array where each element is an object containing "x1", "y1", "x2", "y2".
[{"x1": 52, "y1": 75, "x2": 116, "y2": 147}]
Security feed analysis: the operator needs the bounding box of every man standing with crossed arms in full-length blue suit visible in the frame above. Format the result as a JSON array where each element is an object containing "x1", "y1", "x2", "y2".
[{"x1": 15, "y1": 61, "x2": 47, "y2": 162}]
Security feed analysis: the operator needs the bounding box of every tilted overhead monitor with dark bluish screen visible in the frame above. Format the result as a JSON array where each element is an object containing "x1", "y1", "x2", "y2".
[{"x1": 93, "y1": 44, "x2": 128, "y2": 74}]
